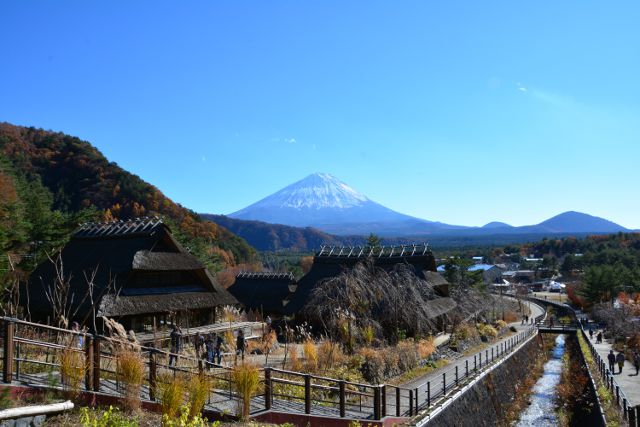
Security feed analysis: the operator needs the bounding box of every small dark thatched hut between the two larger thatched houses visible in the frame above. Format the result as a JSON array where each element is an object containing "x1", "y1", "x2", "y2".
[{"x1": 228, "y1": 272, "x2": 297, "y2": 316}]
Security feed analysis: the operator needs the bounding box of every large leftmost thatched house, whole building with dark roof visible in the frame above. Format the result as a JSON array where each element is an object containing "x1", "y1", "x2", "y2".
[{"x1": 22, "y1": 218, "x2": 237, "y2": 330}]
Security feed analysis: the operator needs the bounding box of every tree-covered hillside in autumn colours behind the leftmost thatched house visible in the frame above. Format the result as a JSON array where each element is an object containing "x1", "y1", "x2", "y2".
[{"x1": 0, "y1": 123, "x2": 256, "y2": 280}]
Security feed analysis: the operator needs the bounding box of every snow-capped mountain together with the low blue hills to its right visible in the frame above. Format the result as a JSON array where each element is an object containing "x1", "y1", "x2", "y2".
[{"x1": 227, "y1": 173, "x2": 629, "y2": 238}]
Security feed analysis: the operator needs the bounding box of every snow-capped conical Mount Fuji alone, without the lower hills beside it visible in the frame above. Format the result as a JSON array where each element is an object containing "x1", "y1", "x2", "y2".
[{"x1": 229, "y1": 173, "x2": 465, "y2": 235}]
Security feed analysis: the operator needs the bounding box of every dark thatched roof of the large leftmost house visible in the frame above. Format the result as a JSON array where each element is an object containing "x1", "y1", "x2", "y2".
[{"x1": 21, "y1": 218, "x2": 237, "y2": 321}]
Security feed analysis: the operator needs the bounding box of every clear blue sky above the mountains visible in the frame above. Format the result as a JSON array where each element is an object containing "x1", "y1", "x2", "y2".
[{"x1": 0, "y1": 0, "x2": 640, "y2": 228}]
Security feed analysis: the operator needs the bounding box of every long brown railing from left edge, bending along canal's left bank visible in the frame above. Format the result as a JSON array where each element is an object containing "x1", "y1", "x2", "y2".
[{"x1": 0, "y1": 306, "x2": 543, "y2": 420}]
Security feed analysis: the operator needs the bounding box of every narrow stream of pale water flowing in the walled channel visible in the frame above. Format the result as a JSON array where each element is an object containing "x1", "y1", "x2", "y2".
[{"x1": 515, "y1": 334, "x2": 564, "y2": 427}]
